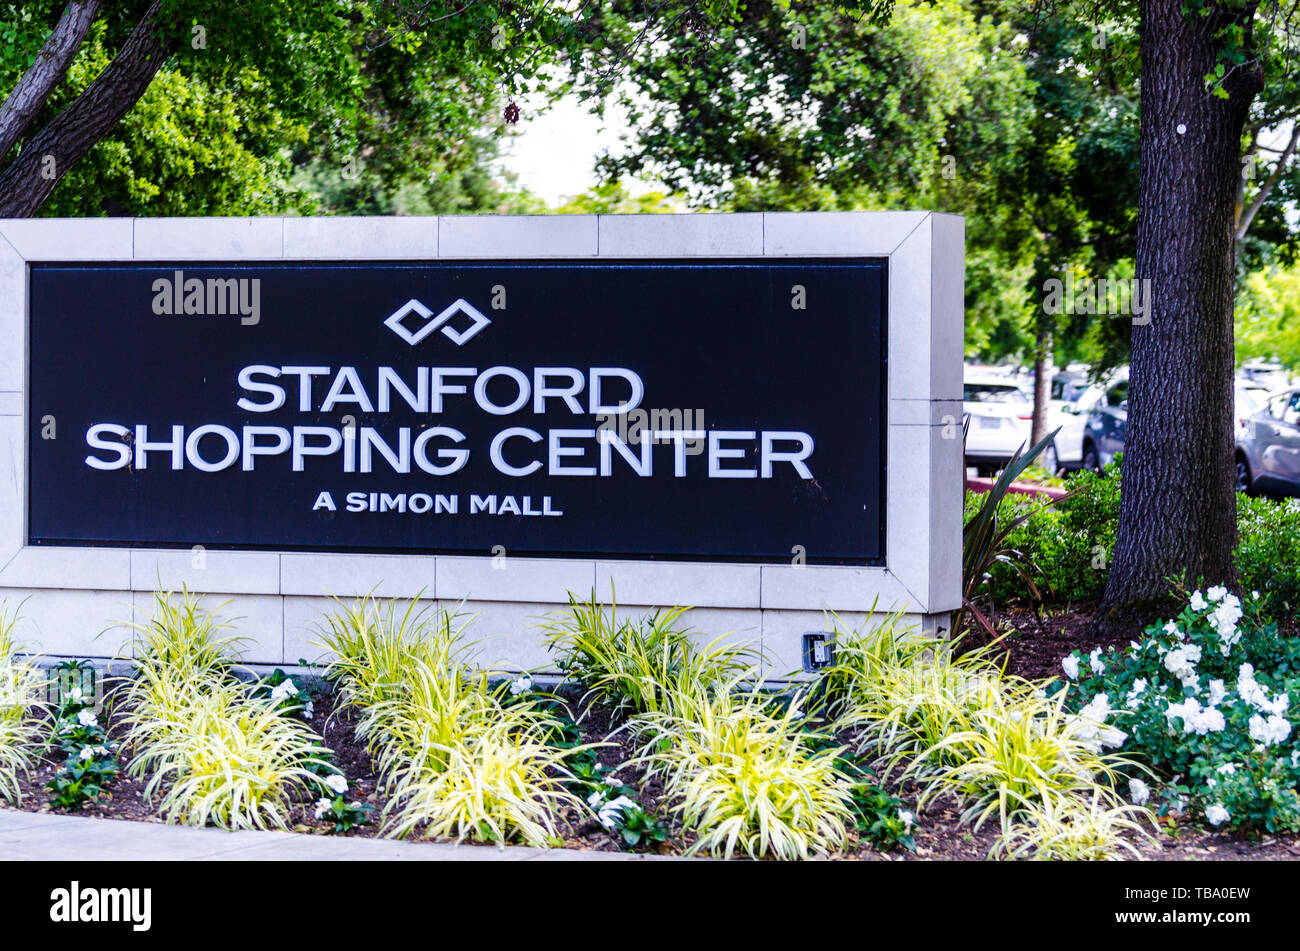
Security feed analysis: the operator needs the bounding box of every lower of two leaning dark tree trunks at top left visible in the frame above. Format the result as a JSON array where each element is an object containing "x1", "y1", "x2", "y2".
[{"x1": 0, "y1": 0, "x2": 174, "y2": 218}]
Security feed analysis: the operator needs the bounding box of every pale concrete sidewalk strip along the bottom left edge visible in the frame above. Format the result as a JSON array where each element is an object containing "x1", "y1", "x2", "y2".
[{"x1": 0, "y1": 809, "x2": 673, "y2": 861}]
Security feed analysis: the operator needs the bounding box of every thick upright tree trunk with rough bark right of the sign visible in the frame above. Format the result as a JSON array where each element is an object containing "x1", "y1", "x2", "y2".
[{"x1": 1096, "y1": 0, "x2": 1262, "y2": 633}]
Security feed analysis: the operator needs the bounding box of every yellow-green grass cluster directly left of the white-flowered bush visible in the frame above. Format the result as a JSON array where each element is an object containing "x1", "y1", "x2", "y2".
[{"x1": 820, "y1": 618, "x2": 1149, "y2": 857}]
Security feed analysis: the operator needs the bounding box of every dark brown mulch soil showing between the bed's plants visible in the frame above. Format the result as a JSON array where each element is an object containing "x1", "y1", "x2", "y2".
[{"x1": 0, "y1": 611, "x2": 1300, "y2": 861}]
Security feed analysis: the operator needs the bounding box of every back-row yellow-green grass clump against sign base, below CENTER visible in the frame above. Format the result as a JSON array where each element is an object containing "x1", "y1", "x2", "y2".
[{"x1": 545, "y1": 592, "x2": 759, "y2": 712}]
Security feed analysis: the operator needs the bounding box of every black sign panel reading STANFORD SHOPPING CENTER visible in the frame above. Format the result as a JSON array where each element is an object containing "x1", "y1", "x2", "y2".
[{"x1": 29, "y1": 259, "x2": 887, "y2": 564}]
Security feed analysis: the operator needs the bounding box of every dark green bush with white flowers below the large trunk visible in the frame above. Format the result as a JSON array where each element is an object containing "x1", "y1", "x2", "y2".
[{"x1": 1054, "y1": 587, "x2": 1300, "y2": 833}]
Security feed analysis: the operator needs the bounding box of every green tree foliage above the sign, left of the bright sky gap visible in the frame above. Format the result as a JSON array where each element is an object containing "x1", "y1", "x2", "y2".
[{"x1": 0, "y1": 0, "x2": 579, "y2": 216}]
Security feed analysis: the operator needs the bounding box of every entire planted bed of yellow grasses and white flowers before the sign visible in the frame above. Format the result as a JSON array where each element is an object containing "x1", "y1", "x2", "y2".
[{"x1": 0, "y1": 589, "x2": 1300, "y2": 860}]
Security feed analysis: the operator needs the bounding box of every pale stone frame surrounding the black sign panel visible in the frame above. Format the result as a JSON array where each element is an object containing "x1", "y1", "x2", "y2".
[{"x1": 0, "y1": 212, "x2": 965, "y2": 660}]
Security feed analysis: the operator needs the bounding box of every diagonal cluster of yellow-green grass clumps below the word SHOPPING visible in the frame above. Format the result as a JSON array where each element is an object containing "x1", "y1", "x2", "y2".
[{"x1": 325, "y1": 598, "x2": 582, "y2": 846}]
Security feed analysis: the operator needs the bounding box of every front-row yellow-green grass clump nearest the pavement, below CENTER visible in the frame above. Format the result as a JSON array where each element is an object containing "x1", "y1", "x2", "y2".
[{"x1": 634, "y1": 685, "x2": 854, "y2": 859}]
